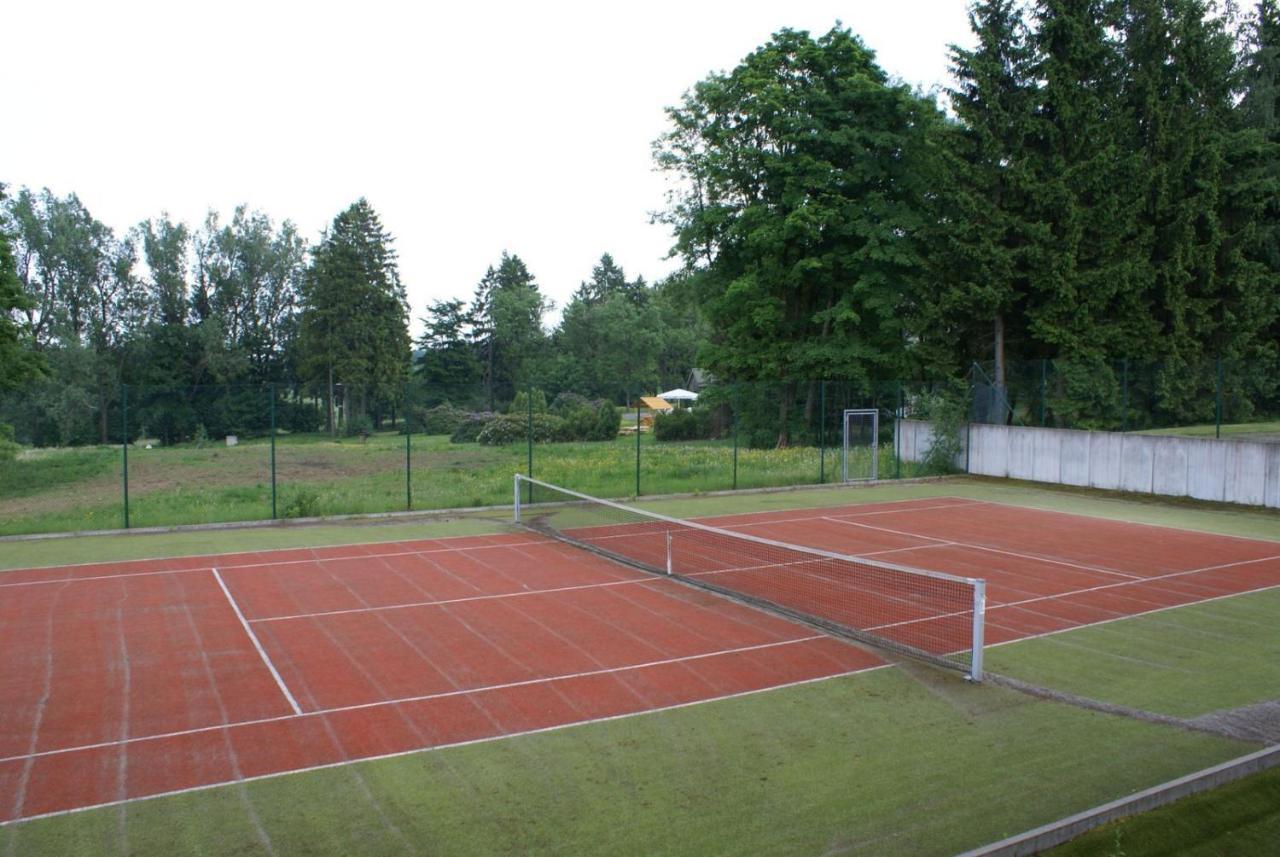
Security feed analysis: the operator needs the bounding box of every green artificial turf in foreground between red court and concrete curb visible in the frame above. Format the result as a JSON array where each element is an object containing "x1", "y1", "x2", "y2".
[{"x1": 0, "y1": 668, "x2": 1248, "y2": 857}]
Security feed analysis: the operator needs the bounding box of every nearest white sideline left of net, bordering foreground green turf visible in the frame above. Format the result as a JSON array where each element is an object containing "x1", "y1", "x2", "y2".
[{"x1": 0, "y1": 664, "x2": 892, "y2": 828}]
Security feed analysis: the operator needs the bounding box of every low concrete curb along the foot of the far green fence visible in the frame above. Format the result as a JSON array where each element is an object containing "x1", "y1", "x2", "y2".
[{"x1": 0, "y1": 476, "x2": 952, "y2": 545}]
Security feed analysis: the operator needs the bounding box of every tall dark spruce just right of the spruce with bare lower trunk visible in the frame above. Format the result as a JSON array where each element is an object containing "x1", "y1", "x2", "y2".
[{"x1": 1027, "y1": 0, "x2": 1157, "y2": 368}]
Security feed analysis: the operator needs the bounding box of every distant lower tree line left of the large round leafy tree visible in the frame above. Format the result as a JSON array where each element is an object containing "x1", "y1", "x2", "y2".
[{"x1": 0, "y1": 188, "x2": 700, "y2": 444}]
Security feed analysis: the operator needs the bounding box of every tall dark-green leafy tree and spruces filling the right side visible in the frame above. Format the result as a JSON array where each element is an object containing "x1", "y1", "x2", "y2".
[{"x1": 655, "y1": 0, "x2": 1280, "y2": 443}]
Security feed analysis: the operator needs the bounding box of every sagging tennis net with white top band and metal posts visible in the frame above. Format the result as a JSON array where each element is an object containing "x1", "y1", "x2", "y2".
[{"x1": 515, "y1": 475, "x2": 986, "y2": 680}]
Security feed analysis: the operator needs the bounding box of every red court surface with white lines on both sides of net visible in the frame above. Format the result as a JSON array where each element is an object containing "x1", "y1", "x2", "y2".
[{"x1": 0, "y1": 498, "x2": 1280, "y2": 822}]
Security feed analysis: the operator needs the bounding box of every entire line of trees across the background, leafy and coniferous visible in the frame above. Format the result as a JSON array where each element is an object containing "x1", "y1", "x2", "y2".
[{"x1": 0, "y1": 0, "x2": 1280, "y2": 445}]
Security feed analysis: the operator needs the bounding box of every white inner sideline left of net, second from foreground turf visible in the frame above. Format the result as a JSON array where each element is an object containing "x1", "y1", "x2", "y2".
[{"x1": 0, "y1": 634, "x2": 831, "y2": 762}]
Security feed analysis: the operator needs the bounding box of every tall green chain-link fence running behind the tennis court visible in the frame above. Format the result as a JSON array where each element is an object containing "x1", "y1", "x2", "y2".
[{"x1": 0, "y1": 361, "x2": 1280, "y2": 535}]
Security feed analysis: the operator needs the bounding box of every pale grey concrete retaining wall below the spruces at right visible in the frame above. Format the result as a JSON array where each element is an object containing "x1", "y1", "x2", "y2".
[{"x1": 895, "y1": 420, "x2": 1280, "y2": 509}]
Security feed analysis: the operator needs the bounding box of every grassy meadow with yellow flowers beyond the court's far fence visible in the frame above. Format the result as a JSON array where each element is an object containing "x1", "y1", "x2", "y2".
[{"x1": 0, "y1": 432, "x2": 916, "y2": 535}]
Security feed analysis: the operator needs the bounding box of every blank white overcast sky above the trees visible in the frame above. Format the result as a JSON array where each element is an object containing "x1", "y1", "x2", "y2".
[{"x1": 0, "y1": 0, "x2": 972, "y2": 333}]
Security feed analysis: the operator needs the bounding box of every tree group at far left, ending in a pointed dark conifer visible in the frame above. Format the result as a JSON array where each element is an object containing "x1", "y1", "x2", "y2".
[{"x1": 4, "y1": 188, "x2": 410, "y2": 444}]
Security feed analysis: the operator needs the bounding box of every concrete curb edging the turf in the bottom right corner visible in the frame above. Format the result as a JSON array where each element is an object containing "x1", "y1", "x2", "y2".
[{"x1": 960, "y1": 744, "x2": 1280, "y2": 857}]
